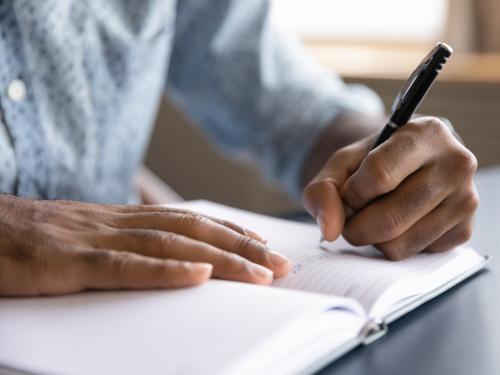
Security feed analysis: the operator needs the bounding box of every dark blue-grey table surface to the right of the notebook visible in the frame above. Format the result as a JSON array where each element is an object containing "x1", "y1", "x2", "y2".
[{"x1": 320, "y1": 168, "x2": 500, "y2": 375}]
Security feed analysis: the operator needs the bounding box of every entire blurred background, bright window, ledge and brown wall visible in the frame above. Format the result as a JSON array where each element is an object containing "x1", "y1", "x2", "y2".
[{"x1": 146, "y1": 0, "x2": 500, "y2": 214}]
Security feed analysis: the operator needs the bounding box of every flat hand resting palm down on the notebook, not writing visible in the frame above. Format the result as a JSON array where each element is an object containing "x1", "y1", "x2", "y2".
[{"x1": 0, "y1": 195, "x2": 291, "y2": 296}]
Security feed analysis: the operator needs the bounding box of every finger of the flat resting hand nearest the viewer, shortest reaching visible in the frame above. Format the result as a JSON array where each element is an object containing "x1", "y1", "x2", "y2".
[{"x1": 74, "y1": 249, "x2": 212, "y2": 289}]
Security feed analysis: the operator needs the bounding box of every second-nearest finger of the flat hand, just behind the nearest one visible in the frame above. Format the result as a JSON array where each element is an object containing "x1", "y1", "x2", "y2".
[{"x1": 87, "y1": 229, "x2": 273, "y2": 285}]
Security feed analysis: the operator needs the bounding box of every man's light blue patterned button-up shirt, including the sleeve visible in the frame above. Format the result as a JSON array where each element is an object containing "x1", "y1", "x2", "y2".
[{"x1": 0, "y1": 0, "x2": 381, "y2": 202}]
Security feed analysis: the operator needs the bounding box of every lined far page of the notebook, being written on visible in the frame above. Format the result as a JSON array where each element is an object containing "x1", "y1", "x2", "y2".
[{"x1": 175, "y1": 201, "x2": 483, "y2": 312}]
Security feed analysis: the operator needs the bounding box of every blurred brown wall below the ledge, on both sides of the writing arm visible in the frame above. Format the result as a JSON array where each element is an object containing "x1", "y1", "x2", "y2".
[{"x1": 146, "y1": 79, "x2": 500, "y2": 213}]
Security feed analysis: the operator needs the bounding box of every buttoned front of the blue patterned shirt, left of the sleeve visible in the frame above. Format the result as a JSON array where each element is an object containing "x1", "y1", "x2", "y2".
[{"x1": 0, "y1": 0, "x2": 174, "y2": 202}]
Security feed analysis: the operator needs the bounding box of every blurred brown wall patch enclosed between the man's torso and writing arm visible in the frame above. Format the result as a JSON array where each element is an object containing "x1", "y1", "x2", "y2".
[{"x1": 146, "y1": 99, "x2": 298, "y2": 214}]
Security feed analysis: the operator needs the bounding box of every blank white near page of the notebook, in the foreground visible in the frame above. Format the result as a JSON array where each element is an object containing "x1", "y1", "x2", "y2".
[{"x1": 0, "y1": 280, "x2": 366, "y2": 375}]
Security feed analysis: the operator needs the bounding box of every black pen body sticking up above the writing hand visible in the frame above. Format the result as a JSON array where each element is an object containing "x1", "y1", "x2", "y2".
[{"x1": 372, "y1": 42, "x2": 453, "y2": 149}]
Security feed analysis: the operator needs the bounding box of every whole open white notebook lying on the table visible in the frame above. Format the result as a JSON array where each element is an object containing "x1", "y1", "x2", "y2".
[{"x1": 0, "y1": 201, "x2": 487, "y2": 375}]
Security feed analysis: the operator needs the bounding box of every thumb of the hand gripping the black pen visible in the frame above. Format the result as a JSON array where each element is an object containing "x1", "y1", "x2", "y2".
[{"x1": 302, "y1": 137, "x2": 372, "y2": 241}]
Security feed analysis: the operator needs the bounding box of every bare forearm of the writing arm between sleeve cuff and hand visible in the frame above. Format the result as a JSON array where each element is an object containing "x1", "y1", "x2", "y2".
[{"x1": 300, "y1": 113, "x2": 384, "y2": 187}]
